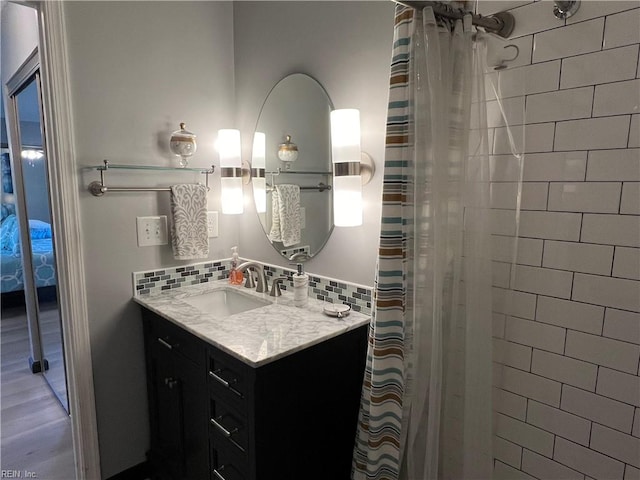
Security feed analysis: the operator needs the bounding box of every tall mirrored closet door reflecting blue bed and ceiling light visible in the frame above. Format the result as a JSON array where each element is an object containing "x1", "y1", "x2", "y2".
[{"x1": 7, "y1": 50, "x2": 69, "y2": 412}]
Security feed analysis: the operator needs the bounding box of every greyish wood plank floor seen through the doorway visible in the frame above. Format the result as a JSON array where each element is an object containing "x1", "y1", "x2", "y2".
[{"x1": 0, "y1": 307, "x2": 75, "y2": 480}]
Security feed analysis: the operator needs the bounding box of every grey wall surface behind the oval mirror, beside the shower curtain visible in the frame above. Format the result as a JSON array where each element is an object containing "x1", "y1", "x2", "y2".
[{"x1": 234, "y1": 1, "x2": 394, "y2": 285}]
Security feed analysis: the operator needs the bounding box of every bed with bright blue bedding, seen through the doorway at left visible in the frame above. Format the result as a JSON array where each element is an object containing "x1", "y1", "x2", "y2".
[{"x1": 0, "y1": 214, "x2": 56, "y2": 296}]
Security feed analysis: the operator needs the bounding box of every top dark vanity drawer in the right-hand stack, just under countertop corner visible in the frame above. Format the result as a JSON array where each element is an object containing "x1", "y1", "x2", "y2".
[{"x1": 207, "y1": 349, "x2": 249, "y2": 411}]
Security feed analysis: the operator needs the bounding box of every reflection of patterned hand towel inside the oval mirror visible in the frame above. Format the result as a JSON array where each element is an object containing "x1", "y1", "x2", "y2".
[{"x1": 269, "y1": 185, "x2": 300, "y2": 247}]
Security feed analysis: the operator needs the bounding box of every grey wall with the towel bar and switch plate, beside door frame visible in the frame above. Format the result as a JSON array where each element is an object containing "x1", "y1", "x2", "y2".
[{"x1": 64, "y1": 2, "x2": 237, "y2": 478}]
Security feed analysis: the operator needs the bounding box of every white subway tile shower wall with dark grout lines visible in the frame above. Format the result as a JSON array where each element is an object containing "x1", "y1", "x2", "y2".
[{"x1": 479, "y1": 1, "x2": 640, "y2": 480}]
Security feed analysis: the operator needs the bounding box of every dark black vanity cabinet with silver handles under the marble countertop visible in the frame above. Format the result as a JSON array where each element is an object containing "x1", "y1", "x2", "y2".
[{"x1": 143, "y1": 308, "x2": 368, "y2": 480}]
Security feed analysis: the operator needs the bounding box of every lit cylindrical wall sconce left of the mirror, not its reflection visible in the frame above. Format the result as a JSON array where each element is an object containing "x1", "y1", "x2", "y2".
[{"x1": 218, "y1": 129, "x2": 244, "y2": 215}]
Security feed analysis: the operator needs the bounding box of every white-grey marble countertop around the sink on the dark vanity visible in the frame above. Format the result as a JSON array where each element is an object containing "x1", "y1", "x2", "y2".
[{"x1": 133, "y1": 280, "x2": 370, "y2": 367}]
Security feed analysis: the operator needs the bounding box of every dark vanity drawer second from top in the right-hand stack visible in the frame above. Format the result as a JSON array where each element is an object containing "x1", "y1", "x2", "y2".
[{"x1": 209, "y1": 398, "x2": 249, "y2": 457}]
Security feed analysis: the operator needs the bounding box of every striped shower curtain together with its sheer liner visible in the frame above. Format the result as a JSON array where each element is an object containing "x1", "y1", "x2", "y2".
[{"x1": 352, "y1": 5, "x2": 492, "y2": 480}]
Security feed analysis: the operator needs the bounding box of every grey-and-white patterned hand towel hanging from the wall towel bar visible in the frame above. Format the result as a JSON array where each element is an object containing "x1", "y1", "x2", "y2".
[{"x1": 171, "y1": 183, "x2": 209, "y2": 260}]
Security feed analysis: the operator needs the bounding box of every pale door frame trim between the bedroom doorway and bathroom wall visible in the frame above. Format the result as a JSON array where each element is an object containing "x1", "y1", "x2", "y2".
[{"x1": 11, "y1": 0, "x2": 101, "y2": 480}]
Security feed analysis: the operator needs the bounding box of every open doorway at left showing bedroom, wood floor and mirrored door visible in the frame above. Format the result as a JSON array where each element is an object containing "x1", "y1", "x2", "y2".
[{"x1": 0, "y1": 49, "x2": 75, "y2": 479}]
